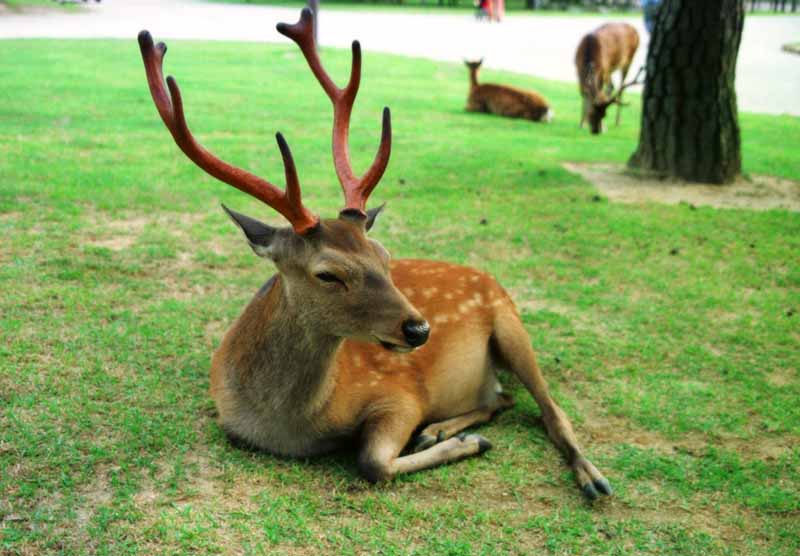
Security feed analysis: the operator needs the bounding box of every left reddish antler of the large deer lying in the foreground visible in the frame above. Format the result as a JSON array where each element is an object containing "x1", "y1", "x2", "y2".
[{"x1": 139, "y1": 31, "x2": 319, "y2": 234}]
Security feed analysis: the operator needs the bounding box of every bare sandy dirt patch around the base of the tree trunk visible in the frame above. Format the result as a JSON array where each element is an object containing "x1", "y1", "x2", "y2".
[{"x1": 564, "y1": 163, "x2": 800, "y2": 212}]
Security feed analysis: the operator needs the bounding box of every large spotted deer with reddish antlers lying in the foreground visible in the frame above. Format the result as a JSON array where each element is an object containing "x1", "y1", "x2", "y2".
[{"x1": 139, "y1": 9, "x2": 612, "y2": 499}]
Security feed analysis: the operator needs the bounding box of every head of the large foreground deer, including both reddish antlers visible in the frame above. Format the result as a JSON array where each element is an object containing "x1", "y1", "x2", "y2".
[{"x1": 139, "y1": 8, "x2": 430, "y2": 351}]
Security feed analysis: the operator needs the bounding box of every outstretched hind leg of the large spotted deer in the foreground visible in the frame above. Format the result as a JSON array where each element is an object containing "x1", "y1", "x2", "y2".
[{"x1": 492, "y1": 310, "x2": 612, "y2": 500}]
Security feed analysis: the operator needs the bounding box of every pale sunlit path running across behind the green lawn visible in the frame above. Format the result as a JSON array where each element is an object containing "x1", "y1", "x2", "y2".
[{"x1": 0, "y1": 0, "x2": 800, "y2": 115}]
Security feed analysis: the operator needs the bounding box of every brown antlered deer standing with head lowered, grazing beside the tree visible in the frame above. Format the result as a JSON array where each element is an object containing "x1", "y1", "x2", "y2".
[{"x1": 575, "y1": 23, "x2": 641, "y2": 134}]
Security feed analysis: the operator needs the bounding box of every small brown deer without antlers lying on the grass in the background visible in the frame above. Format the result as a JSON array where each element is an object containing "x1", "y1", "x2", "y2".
[{"x1": 464, "y1": 59, "x2": 553, "y2": 123}]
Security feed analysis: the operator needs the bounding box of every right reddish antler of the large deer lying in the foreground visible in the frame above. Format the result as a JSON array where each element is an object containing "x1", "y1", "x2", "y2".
[{"x1": 277, "y1": 8, "x2": 392, "y2": 216}]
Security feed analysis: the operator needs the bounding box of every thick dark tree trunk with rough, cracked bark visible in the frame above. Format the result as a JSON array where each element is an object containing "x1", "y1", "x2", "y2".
[{"x1": 628, "y1": 0, "x2": 744, "y2": 187}]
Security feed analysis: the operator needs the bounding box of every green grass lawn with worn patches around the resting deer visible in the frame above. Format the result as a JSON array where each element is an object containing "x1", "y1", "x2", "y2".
[{"x1": 0, "y1": 37, "x2": 800, "y2": 556}]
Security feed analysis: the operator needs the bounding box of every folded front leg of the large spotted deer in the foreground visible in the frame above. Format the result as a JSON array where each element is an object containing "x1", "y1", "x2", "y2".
[{"x1": 358, "y1": 400, "x2": 492, "y2": 482}]
